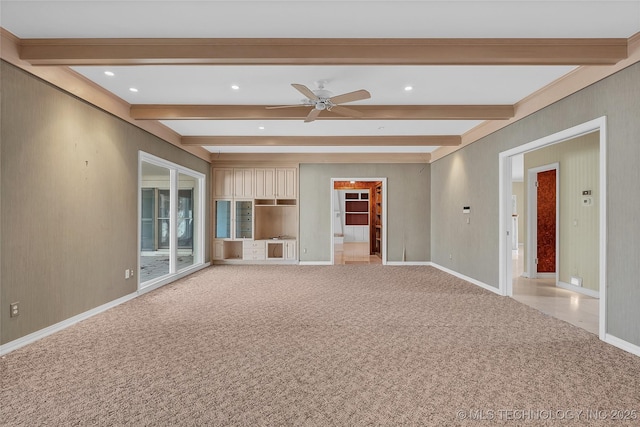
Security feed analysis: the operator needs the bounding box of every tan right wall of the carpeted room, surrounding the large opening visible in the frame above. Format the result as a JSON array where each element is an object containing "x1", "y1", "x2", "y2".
[{"x1": 431, "y1": 63, "x2": 640, "y2": 345}]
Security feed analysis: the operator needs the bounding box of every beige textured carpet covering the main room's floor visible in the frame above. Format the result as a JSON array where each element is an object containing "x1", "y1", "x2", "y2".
[{"x1": 0, "y1": 265, "x2": 640, "y2": 426}]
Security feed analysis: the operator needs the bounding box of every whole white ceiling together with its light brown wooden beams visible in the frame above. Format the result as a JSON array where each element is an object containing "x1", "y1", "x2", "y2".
[{"x1": 0, "y1": 0, "x2": 640, "y2": 159}]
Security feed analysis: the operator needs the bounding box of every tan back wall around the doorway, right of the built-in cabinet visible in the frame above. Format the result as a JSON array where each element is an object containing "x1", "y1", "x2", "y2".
[{"x1": 300, "y1": 163, "x2": 431, "y2": 262}]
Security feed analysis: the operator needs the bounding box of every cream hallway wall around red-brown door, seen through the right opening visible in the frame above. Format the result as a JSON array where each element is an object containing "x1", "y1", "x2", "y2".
[{"x1": 524, "y1": 132, "x2": 600, "y2": 291}]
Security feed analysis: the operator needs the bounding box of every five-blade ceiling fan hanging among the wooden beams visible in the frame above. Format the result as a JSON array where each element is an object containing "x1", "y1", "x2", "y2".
[{"x1": 267, "y1": 82, "x2": 371, "y2": 123}]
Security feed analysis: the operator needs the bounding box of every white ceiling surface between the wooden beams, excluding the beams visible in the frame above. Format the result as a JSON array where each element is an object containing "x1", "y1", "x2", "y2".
[{"x1": 0, "y1": 0, "x2": 640, "y2": 158}]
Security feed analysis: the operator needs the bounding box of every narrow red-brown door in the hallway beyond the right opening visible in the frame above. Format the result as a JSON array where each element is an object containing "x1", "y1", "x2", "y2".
[{"x1": 537, "y1": 169, "x2": 556, "y2": 273}]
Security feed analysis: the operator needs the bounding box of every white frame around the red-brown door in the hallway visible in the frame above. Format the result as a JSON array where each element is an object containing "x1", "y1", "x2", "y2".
[{"x1": 527, "y1": 163, "x2": 560, "y2": 285}]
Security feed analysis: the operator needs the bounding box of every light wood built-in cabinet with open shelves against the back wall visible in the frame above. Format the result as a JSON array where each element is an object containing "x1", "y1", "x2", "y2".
[{"x1": 213, "y1": 167, "x2": 298, "y2": 263}]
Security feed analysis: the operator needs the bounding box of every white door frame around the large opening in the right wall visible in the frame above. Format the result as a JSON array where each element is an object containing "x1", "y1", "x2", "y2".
[{"x1": 498, "y1": 116, "x2": 607, "y2": 340}]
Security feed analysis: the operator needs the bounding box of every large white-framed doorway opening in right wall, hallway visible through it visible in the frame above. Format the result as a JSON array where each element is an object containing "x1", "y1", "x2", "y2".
[{"x1": 499, "y1": 117, "x2": 606, "y2": 340}]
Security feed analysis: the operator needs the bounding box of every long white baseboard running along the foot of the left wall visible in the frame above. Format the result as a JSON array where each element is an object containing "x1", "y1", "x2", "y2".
[{"x1": 0, "y1": 263, "x2": 210, "y2": 356}]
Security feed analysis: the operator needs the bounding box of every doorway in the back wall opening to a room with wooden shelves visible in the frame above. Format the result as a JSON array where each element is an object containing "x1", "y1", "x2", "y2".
[{"x1": 331, "y1": 178, "x2": 386, "y2": 264}]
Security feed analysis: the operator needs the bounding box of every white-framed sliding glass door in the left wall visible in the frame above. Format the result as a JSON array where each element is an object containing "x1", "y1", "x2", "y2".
[{"x1": 138, "y1": 153, "x2": 204, "y2": 288}]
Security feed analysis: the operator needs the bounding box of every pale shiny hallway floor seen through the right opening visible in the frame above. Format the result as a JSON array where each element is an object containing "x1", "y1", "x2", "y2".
[{"x1": 513, "y1": 245, "x2": 599, "y2": 335}]
